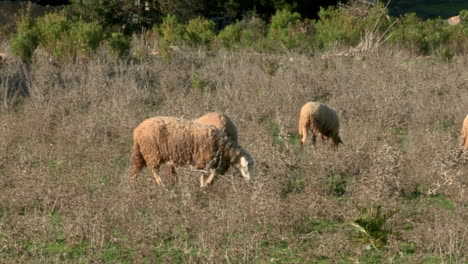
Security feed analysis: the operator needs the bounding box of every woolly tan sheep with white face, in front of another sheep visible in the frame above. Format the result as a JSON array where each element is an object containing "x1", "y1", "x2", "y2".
[{"x1": 130, "y1": 116, "x2": 253, "y2": 188}]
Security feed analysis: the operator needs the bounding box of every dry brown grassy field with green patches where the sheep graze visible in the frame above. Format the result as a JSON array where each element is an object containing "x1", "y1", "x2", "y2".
[{"x1": 0, "y1": 49, "x2": 468, "y2": 263}]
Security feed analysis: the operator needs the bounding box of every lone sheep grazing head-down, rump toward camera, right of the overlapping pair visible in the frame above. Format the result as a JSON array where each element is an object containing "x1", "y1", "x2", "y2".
[{"x1": 299, "y1": 102, "x2": 343, "y2": 150}]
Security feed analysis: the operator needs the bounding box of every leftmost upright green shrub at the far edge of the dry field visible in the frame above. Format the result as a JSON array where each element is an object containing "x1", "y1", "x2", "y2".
[{"x1": 10, "y1": 11, "x2": 39, "y2": 62}]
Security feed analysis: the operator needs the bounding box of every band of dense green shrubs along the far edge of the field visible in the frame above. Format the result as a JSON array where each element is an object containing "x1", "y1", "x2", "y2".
[{"x1": 11, "y1": 0, "x2": 468, "y2": 61}]
